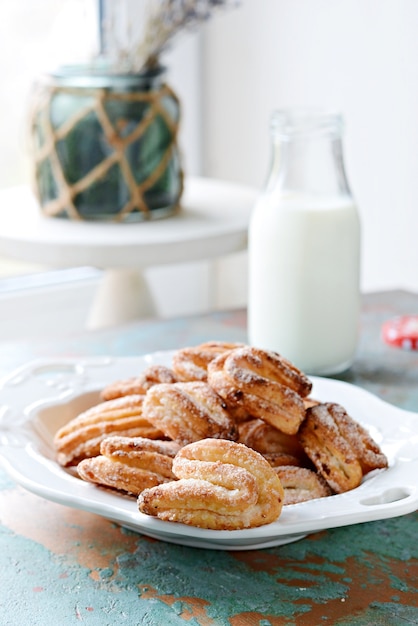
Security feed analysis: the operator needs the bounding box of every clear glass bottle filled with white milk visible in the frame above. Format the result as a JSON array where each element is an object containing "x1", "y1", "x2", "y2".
[{"x1": 248, "y1": 110, "x2": 360, "y2": 375}]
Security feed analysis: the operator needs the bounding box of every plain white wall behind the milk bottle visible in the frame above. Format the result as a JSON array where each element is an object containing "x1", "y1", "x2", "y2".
[{"x1": 203, "y1": 0, "x2": 418, "y2": 299}]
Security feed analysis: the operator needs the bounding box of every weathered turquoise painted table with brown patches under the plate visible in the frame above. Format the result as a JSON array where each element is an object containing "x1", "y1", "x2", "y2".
[{"x1": 0, "y1": 291, "x2": 418, "y2": 626}]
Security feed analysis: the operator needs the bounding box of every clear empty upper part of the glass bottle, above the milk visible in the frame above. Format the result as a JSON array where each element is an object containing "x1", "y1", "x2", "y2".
[{"x1": 267, "y1": 109, "x2": 350, "y2": 196}]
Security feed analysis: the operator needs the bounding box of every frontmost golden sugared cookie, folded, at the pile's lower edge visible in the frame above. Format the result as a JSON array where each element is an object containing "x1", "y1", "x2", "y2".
[{"x1": 138, "y1": 439, "x2": 283, "y2": 530}]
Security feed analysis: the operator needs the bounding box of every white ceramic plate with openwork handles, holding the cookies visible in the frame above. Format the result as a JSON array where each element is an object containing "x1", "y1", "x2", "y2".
[{"x1": 0, "y1": 352, "x2": 418, "y2": 550}]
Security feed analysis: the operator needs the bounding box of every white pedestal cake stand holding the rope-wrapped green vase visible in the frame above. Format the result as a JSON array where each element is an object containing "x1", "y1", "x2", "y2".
[{"x1": 0, "y1": 177, "x2": 257, "y2": 328}]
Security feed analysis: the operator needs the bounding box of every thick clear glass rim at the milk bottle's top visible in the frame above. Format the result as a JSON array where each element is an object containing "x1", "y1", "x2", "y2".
[{"x1": 271, "y1": 108, "x2": 344, "y2": 137}]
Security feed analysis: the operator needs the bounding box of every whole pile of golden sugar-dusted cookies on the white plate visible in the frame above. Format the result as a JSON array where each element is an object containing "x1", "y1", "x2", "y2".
[{"x1": 54, "y1": 341, "x2": 388, "y2": 530}]
